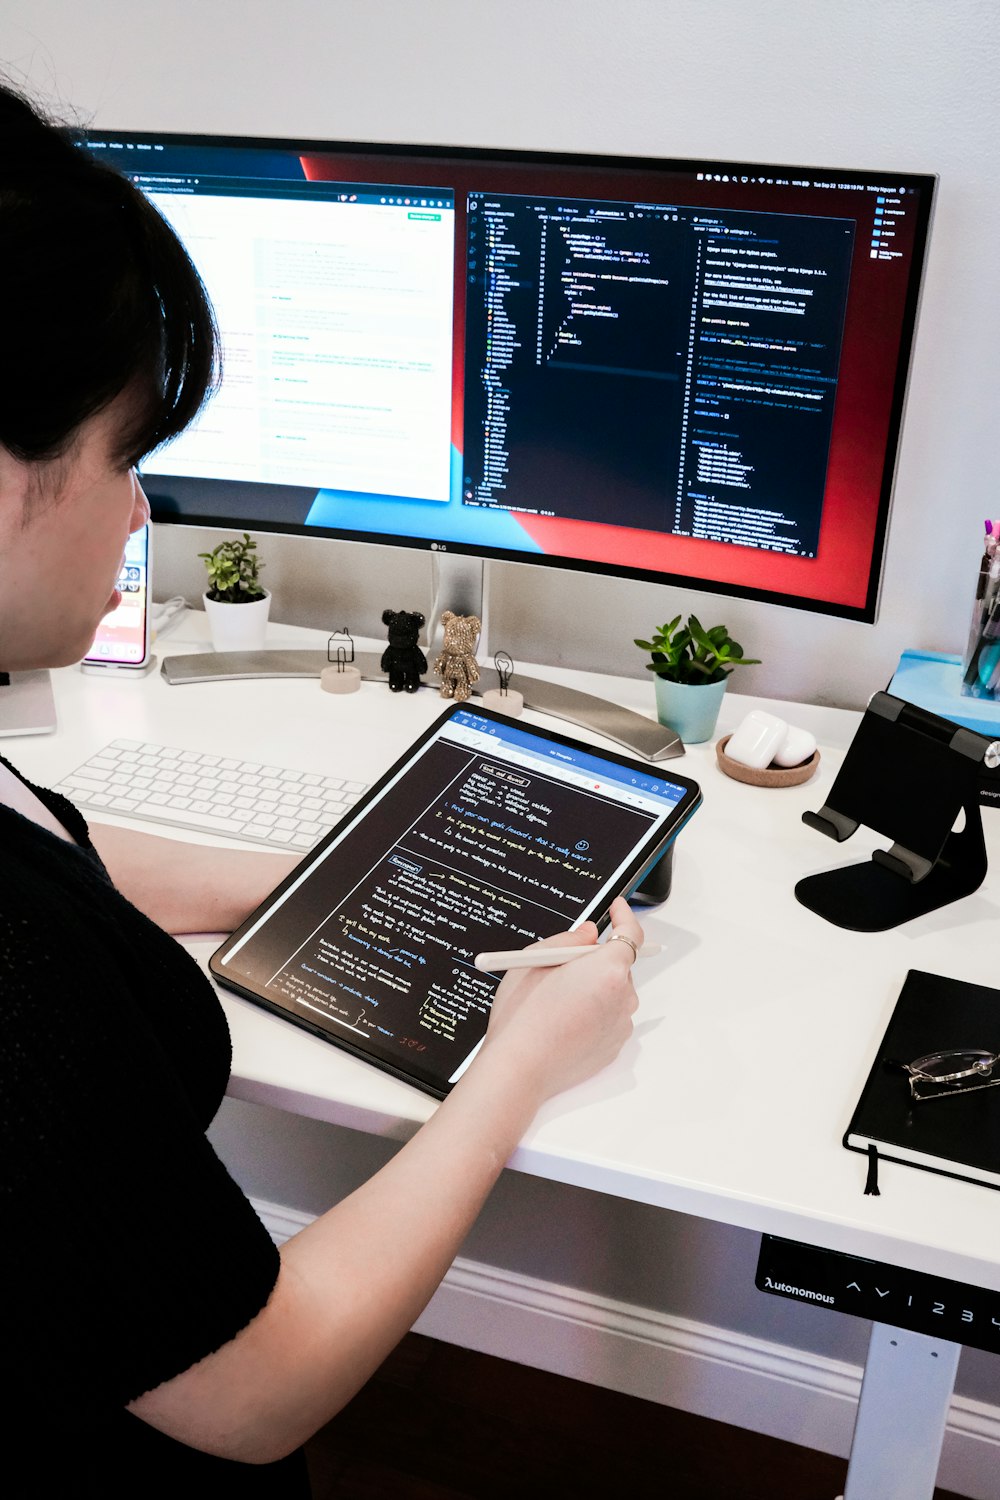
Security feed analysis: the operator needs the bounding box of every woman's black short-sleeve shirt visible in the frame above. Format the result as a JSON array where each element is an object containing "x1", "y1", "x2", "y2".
[{"x1": 0, "y1": 768, "x2": 307, "y2": 1497}]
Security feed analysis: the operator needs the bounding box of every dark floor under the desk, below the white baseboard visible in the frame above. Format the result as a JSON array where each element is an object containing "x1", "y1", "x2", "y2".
[{"x1": 302, "y1": 1334, "x2": 958, "y2": 1500}]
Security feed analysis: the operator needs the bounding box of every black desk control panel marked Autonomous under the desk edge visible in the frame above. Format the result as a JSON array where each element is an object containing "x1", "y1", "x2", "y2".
[{"x1": 756, "y1": 1235, "x2": 1000, "y2": 1355}]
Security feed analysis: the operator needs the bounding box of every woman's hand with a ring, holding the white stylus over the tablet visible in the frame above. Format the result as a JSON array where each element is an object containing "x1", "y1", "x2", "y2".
[{"x1": 469, "y1": 897, "x2": 643, "y2": 1104}]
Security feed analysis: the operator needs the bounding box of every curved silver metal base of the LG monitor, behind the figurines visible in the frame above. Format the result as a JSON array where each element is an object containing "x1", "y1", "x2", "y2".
[{"x1": 160, "y1": 650, "x2": 684, "y2": 761}]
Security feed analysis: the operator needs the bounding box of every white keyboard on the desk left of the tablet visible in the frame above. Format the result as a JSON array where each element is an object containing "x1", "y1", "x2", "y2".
[{"x1": 54, "y1": 740, "x2": 367, "y2": 849}]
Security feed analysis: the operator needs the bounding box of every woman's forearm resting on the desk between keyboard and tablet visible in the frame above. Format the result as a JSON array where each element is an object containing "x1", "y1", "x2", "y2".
[{"x1": 90, "y1": 824, "x2": 301, "y2": 933}]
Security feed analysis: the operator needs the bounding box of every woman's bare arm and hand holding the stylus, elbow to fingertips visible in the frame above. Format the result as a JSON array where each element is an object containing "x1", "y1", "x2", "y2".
[{"x1": 130, "y1": 902, "x2": 642, "y2": 1463}]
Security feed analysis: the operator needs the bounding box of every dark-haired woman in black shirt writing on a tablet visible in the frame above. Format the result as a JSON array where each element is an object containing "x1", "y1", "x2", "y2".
[{"x1": 0, "y1": 89, "x2": 642, "y2": 1497}]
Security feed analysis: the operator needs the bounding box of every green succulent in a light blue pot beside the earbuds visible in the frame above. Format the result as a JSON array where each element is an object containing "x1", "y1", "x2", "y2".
[{"x1": 636, "y1": 615, "x2": 759, "y2": 744}]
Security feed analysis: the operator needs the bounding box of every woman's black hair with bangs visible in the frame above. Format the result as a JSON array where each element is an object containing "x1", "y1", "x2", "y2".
[{"x1": 0, "y1": 81, "x2": 219, "y2": 468}]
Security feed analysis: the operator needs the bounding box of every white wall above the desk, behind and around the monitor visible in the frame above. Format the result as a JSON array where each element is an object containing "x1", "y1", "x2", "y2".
[{"x1": 0, "y1": 0, "x2": 1000, "y2": 707}]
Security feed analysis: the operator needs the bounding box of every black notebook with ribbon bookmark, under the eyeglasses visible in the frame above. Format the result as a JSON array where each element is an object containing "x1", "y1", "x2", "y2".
[{"x1": 844, "y1": 969, "x2": 1000, "y2": 1188}]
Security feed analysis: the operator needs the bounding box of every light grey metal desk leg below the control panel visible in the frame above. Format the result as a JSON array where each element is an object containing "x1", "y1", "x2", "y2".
[{"x1": 844, "y1": 1323, "x2": 961, "y2": 1500}]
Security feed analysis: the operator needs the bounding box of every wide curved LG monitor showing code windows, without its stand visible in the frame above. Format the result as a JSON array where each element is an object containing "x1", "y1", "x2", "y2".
[{"x1": 88, "y1": 132, "x2": 934, "y2": 620}]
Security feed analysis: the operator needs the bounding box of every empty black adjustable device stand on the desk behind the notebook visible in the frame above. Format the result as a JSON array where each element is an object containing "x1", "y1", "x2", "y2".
[{"x1": 795, "y1": 693, "x2": 1000, "y2": 933}]
